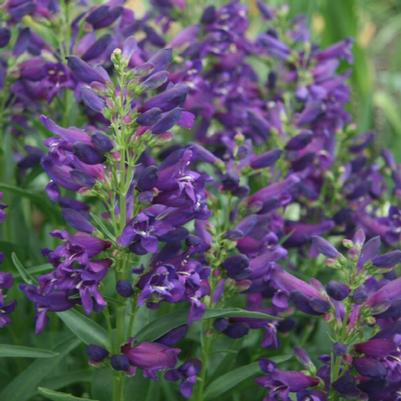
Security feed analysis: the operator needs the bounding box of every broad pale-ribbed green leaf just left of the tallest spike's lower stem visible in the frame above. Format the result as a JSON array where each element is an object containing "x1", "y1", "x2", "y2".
[{"x1": 57, "y1": 309, "x2": 110, "y2": 349}]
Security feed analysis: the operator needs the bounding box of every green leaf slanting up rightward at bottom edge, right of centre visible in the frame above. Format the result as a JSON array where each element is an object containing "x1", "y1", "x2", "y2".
[{"x1": 205, "y1": 362, "x2": 260, "y2": 400}]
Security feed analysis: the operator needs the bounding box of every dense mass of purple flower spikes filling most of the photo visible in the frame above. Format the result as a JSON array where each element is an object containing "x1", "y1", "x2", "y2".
[{"x1": 0, "y1": 0, "x2": 401, "y2": 401}]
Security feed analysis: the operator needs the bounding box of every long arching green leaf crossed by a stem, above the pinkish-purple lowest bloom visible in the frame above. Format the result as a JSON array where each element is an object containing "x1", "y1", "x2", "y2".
[{"x1": 138, "y1": 308, "x2": 280, "y2": 341}]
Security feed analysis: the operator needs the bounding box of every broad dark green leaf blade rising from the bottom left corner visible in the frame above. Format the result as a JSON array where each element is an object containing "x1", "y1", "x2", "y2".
[{"x1": 0, "y1": 338, "x2": 80, "y2": 401}]
